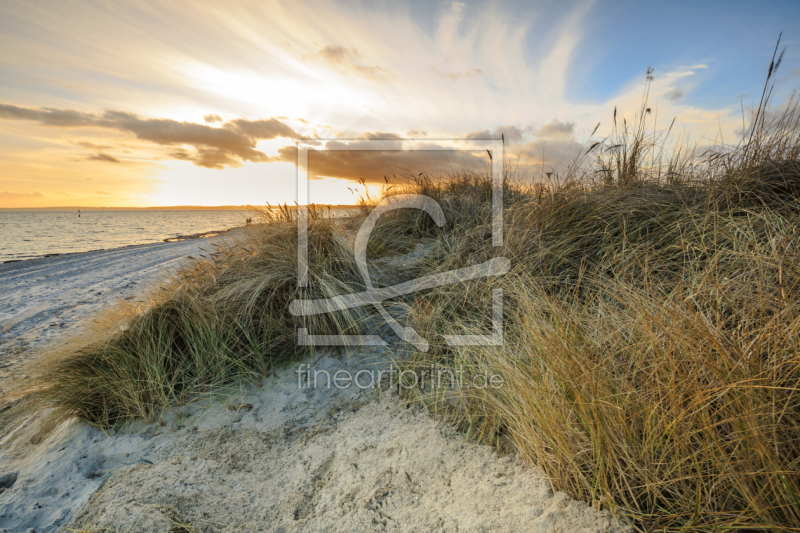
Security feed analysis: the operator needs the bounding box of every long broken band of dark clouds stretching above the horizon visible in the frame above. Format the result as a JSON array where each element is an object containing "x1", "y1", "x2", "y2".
[{"x1": 0, "y1": 104, "x2": 575, "y2": 182}]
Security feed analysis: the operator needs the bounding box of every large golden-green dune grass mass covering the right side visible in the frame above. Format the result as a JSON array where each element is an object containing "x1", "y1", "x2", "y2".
[{"x1": 380, "y1": 77, "x2": 800, "y2": 531}]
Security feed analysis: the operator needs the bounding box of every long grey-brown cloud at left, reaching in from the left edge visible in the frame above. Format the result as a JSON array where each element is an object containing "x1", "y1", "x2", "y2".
[{"x1": 0, "y1": 104, "x2": 300, "y2": 169}]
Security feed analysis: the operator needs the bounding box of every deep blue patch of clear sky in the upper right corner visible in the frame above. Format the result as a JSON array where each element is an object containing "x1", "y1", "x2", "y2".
[{"x1": 569, "y1": 1, "x2": 800, "y2": 107}]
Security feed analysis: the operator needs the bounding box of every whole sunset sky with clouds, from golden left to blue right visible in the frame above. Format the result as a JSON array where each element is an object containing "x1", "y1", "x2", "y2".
[{"x1": 0, "y1": 0, "x2": 800, "y2": 208}]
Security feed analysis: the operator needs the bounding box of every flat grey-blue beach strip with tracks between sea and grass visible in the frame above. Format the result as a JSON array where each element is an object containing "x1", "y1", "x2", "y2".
[{"x1": 0, "y1": 230, "x2": 245, "y2": 388}]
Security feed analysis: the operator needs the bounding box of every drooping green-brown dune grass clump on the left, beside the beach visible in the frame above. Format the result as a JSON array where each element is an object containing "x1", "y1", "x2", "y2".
[{"x1": 12, "y1": 210, "x2": 362, "y2": 427}]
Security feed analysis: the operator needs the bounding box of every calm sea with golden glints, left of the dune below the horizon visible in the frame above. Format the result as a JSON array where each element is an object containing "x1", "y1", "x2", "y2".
[{"x1": 0, "y1": 210, "x2": 254, "y2": 262}]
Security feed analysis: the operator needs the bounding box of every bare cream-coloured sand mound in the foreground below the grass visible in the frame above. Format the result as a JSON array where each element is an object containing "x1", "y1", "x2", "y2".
[{"x1": 72, "y1": 395, "x2": 623, "y2": 533}]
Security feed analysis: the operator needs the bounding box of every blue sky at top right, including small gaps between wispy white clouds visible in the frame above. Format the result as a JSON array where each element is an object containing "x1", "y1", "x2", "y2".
[{"x1": 408, "y1": 0, "x2": 800, "y2": 106}]
